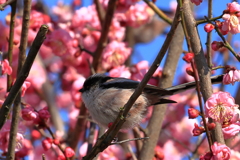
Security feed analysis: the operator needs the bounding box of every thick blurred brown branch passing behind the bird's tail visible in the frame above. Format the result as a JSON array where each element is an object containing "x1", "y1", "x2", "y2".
[{"x1": 138, "y1": 6, "x2": 184, "y2": 160}]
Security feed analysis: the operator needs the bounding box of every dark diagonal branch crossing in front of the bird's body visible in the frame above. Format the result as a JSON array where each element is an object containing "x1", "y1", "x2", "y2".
[{"x1": 83, "y1": 4, "x2": 179, "y2": 160}]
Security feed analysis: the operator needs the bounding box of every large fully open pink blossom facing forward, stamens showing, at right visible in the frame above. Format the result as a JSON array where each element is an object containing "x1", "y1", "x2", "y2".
[{"x1": 205, "y1": 91, "x2": 238, "y2": 123}]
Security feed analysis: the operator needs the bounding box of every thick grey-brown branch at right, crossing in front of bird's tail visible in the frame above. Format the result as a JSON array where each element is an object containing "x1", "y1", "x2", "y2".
[{"x1": 183, "y1": 0, "x2": 225, "y2": 144}]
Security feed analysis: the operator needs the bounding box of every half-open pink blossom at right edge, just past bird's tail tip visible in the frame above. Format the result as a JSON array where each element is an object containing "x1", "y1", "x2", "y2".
[{"x1": 223, "y1": 69, "x2": 240, "y2": 85}]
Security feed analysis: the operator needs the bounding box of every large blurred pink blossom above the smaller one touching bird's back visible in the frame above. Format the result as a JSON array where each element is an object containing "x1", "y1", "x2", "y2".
[{"x1": 102, "y1": 41, "x2": 132, "y2": 69}]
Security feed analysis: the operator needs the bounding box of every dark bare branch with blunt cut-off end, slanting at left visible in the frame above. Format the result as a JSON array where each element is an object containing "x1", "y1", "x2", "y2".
[{"x1": 0, "y1": 25, "x2": 48, "y2": 129}]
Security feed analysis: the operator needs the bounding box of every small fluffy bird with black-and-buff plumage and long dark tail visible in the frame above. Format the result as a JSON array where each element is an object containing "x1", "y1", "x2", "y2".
[{"x1": 79, "y1": 74, "x2": 223, "y2": 130}]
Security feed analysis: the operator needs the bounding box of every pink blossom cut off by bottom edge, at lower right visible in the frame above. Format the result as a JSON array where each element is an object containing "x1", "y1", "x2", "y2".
[{"x1": 211, "y1": 142, "x2": 231, "y2": 160}]
